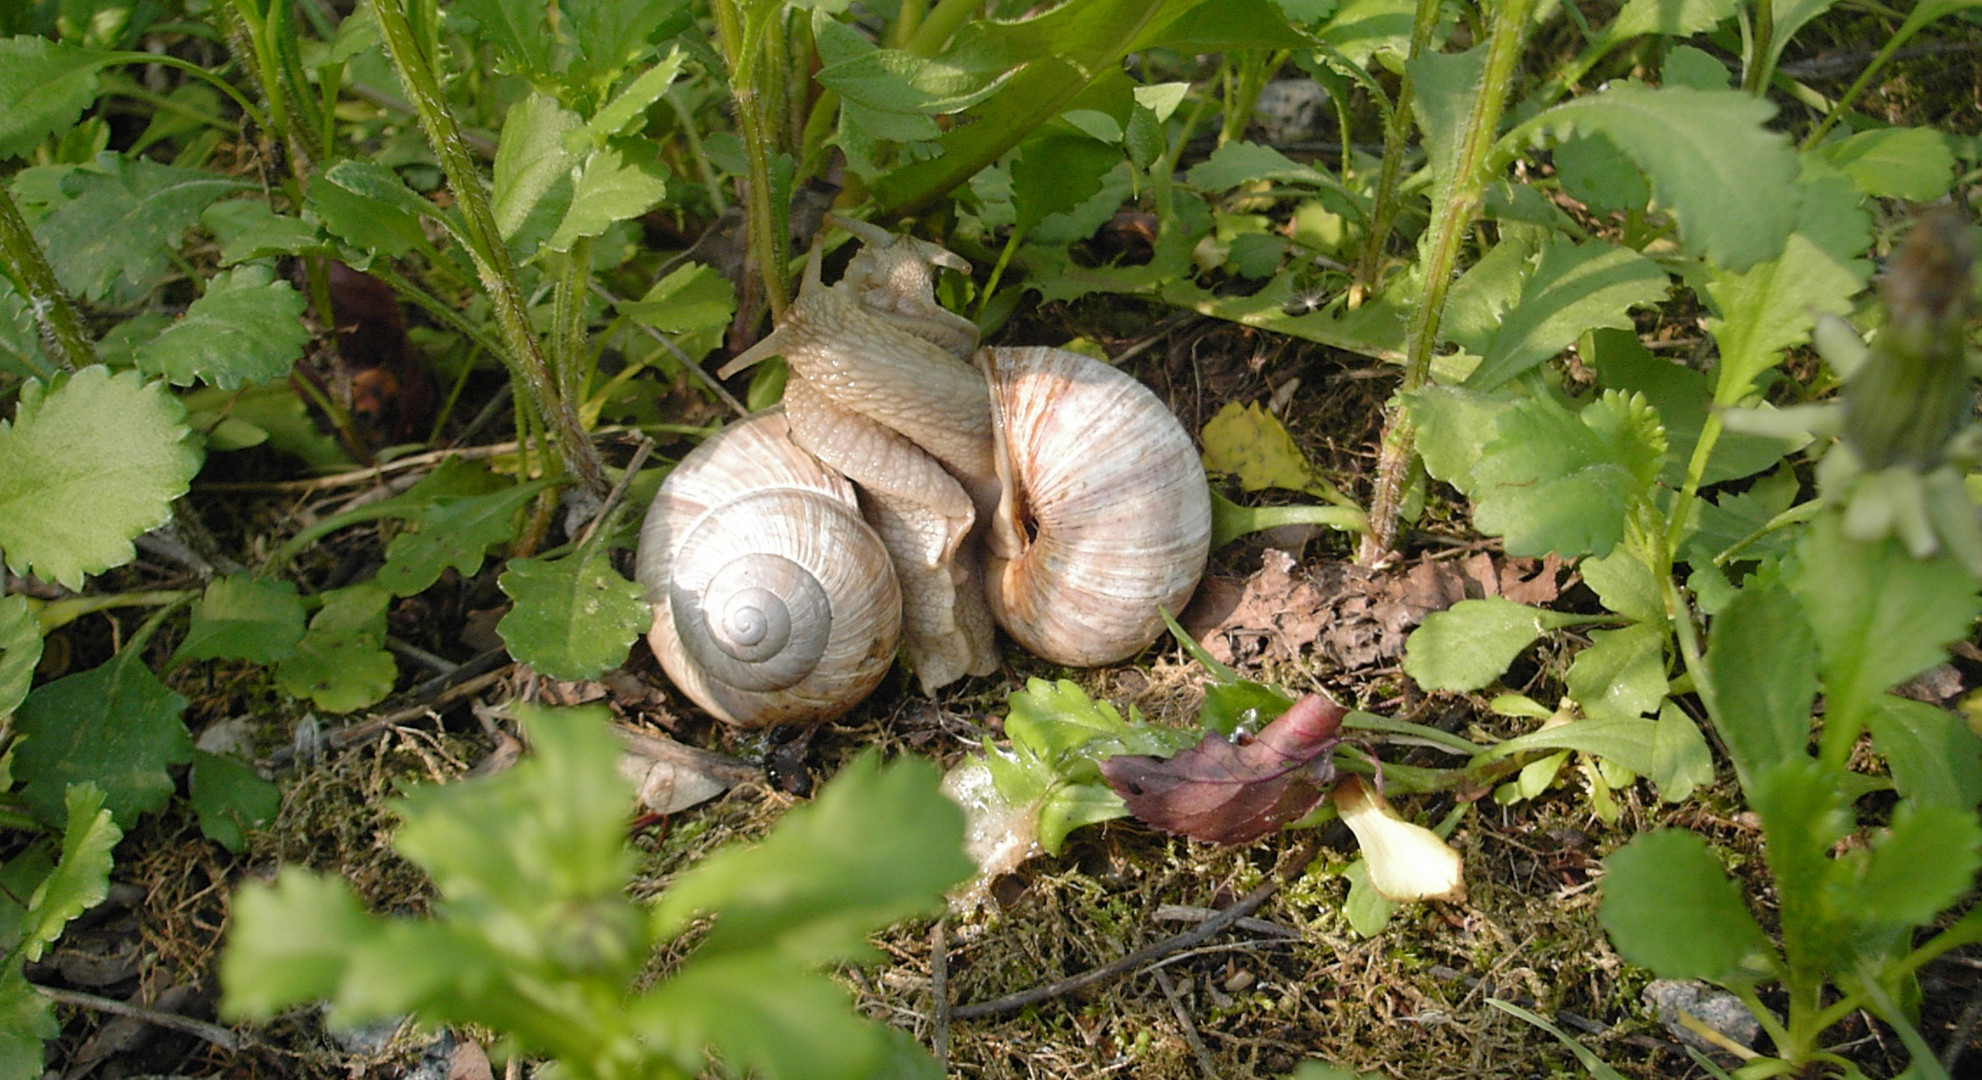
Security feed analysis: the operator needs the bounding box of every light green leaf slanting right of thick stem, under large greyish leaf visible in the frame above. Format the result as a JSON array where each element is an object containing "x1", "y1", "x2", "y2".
[{"x1": 1467, "y1": 240, "x2": 1667, "y2": 390}]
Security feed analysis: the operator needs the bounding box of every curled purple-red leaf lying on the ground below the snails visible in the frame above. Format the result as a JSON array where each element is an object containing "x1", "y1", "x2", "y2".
[{"x1": 1100, "y1": 694, "x2": 1346, "y2": 844}]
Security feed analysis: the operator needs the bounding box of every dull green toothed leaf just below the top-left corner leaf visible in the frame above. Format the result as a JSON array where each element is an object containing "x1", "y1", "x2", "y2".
[{"x1": 34, "y1": 153, "x2": 248, "y2": 299}]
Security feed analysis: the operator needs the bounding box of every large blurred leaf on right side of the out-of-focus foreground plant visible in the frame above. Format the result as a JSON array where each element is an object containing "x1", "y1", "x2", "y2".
[{"x1": 654, "y1": 753, "x2": 975, "y2": 965}]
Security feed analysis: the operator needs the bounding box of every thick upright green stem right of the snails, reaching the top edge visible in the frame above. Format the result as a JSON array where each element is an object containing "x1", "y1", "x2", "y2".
[{"x1": 1356, "y1": 0, "x2": 1534, "y2": 567}]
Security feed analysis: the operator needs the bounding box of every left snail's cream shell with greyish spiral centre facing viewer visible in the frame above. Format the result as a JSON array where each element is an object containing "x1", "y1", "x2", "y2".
[{"x1": 636, "y1": 412, "x2": 902, "y2": 727}]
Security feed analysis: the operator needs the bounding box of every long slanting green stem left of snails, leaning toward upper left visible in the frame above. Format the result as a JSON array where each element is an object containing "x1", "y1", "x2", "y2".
[{"x1": 371, "y1": 0, "x2": 610, "y2": 495}]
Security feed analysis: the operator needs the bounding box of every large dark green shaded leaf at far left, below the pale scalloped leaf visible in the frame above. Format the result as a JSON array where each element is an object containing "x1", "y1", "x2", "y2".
[{"x1": 14, "y1": 650, "x2": 192, "y2": 826}]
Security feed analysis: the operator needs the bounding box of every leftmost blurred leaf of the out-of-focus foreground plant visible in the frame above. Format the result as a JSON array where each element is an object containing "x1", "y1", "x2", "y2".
[{"x1": 220, "y1": 866, "x2": 383, "y2": 1021}]
